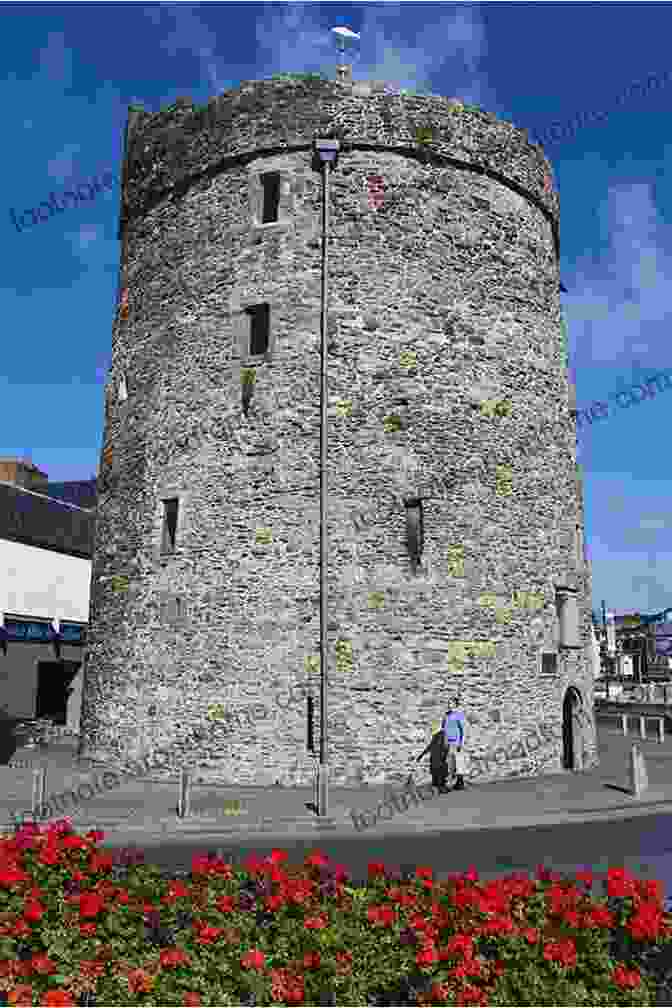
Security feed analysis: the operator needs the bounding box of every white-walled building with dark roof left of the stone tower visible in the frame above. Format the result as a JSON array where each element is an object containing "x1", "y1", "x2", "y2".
[{"x1": 0, "y1": 459, "x2": 96, "y2": 732}]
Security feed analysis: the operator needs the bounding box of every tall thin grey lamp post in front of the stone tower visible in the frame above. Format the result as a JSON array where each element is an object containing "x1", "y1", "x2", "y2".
[{"x1": 314, "y1": 139, "x2": 341, "y2": 816}]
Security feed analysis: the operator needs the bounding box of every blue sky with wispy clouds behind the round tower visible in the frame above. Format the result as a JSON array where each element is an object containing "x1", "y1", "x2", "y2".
[{"x1": 0, "y1": 2, "x2": 672, "y2": 613}]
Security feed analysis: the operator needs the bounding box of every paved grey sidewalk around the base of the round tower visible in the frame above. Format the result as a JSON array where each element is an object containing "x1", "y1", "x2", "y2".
[{"x1": 0, "y1": 724, "x2": 672, "y2": 844}]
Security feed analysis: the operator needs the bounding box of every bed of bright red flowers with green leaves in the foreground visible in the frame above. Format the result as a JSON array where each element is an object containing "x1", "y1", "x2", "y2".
[{"x1": 0, "y1": 821, "x2": 672, "y2": 1006}]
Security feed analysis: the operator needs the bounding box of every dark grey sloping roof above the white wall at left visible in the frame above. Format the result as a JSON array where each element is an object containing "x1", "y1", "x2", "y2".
[{"x1": 0, "y1": 481, "x2": 96, "y2": 559}]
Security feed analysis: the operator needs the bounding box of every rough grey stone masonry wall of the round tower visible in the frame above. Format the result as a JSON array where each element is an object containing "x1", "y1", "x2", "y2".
[{"x1": 82, "y1": 81, "x2": 596, "y2": 784}]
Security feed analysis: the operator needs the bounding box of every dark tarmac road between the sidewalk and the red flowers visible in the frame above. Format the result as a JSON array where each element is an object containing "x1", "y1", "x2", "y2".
[{"x1": 102, "y1": 813, "x2": 672, "y2": 894}]
